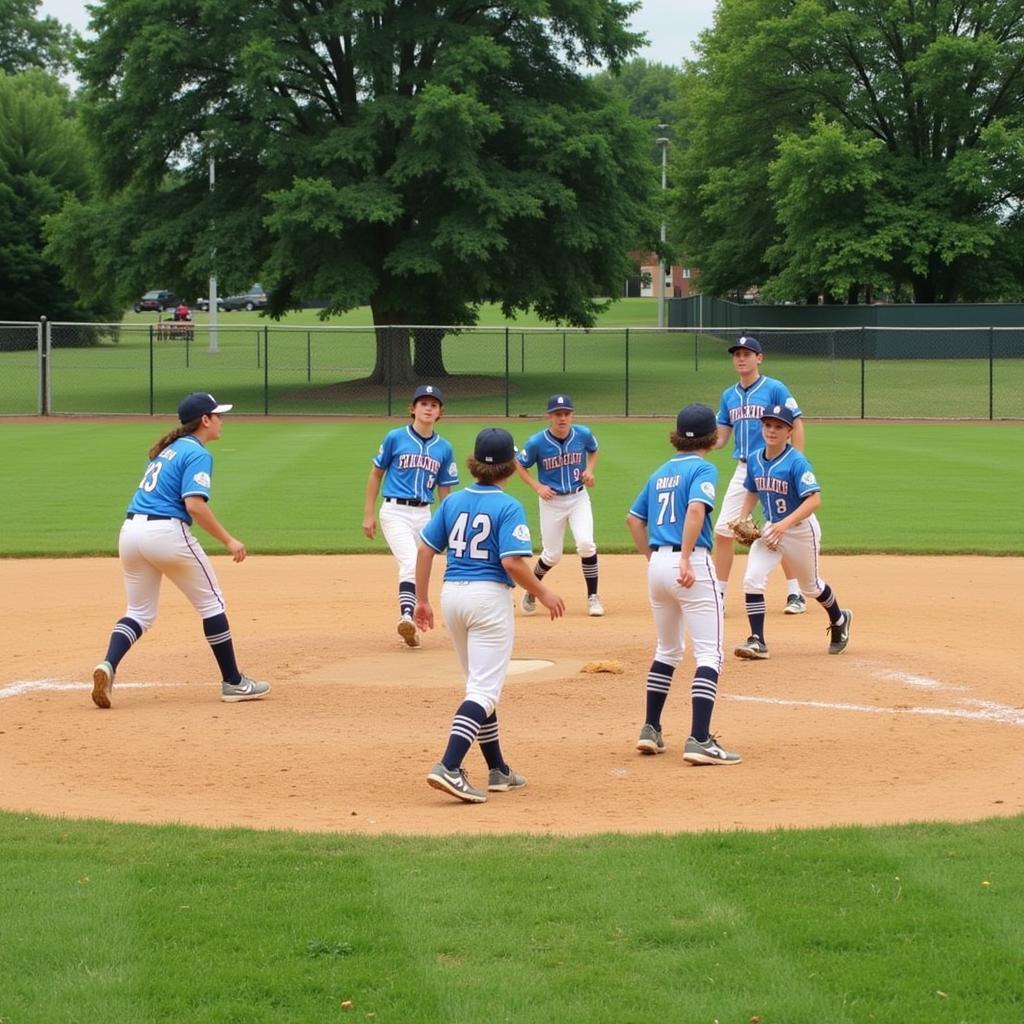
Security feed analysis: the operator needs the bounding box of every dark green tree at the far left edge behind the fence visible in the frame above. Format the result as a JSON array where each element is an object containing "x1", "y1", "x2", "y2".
[{"x1": 0, "y1": 71, "x2": 116, "y2": 321}]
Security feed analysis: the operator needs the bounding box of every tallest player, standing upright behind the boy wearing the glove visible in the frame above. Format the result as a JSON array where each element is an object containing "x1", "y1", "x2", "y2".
[{"x1": 715, "y1": 335, "x2": 807, "y2": 615}]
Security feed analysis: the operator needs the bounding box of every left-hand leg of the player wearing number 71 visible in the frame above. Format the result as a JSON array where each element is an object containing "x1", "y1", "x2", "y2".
[{"x1": 636, "y1": 551, "x2": 686, "y2": 754}]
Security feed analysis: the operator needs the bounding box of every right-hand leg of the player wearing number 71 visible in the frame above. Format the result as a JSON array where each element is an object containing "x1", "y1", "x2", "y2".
[{"x1": 679, "y1": 549, "x2": 742, "y2": 765}]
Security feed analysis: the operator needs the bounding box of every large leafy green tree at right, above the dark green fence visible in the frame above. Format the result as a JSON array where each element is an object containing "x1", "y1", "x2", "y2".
[{"x1": 675, "y1": 0, "x2": 1024, "y2": 302}]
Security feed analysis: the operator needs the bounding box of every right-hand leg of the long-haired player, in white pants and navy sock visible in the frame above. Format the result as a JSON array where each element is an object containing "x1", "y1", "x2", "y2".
[{"x1": 154, "y1": 519, "x2": 270, "y2": 702}]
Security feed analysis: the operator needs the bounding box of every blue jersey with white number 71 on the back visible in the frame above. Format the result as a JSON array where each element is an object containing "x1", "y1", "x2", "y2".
[{"x1": 630, "y1": 452, "x2": 718, "y2": 550}]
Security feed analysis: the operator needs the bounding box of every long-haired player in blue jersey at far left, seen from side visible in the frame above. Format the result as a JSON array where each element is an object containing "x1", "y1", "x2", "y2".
[{"x1": 92, "y1": 391, "x2": 270, "y2": 708}]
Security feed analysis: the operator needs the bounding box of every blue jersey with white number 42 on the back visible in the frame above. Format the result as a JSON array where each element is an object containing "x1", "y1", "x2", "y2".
[{"x1": 420, "y1": 483, "x2": 534, "y2": 587}]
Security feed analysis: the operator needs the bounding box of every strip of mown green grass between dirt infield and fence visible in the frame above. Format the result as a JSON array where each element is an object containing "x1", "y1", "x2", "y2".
[{"x1": 0, "y1": 419, "x2": 1024, "y2": 556}]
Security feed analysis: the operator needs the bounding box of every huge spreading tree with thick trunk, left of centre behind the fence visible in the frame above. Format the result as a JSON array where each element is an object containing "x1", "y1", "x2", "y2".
[{"x1": 54, "y1": 0, "x2": 653, "y2": 381}]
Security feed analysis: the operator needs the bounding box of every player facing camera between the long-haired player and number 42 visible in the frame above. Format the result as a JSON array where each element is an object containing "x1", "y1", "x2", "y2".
[{"x1": 362, "y1": 384, "x2": 459, "y2": 647}]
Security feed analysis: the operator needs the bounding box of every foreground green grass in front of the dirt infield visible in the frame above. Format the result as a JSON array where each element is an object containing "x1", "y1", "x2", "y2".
[{"x1": 0, "y1": 814, "x2": 1024, "y2": 1024}]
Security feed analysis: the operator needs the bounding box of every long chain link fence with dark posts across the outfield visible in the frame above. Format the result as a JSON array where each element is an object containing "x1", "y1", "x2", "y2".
[{"x1": 0, "y1": 321, "x2": 1024, "y2": 420}]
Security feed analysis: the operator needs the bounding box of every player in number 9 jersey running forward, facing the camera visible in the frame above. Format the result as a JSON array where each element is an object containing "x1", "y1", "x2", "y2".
[{"x1": 515, "y1": 394, "x2": 604, "y2": 615}]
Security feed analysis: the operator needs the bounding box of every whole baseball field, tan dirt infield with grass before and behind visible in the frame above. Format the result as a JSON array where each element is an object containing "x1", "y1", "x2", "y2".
[{"x1": 0, "y1": 411, "x2": 1024, "y2": 1024}]
